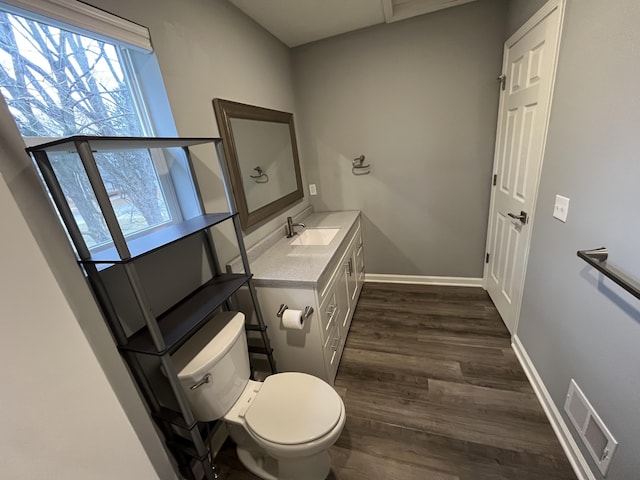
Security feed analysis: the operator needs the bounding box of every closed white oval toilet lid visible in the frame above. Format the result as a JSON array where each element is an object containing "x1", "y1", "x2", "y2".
[{"x1": 245, "y1": 372, "x2": 342, "y2": 445}]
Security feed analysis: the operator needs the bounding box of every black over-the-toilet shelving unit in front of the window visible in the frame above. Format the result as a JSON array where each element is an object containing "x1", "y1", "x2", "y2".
[{"x1": 27, "y1": 135, "x2": 276, "y2": 479}]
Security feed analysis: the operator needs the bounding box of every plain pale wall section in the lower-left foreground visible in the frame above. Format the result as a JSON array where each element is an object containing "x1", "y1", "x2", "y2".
[{"x1": 0, "y1": 158, "x2": 160, "y2": 480}]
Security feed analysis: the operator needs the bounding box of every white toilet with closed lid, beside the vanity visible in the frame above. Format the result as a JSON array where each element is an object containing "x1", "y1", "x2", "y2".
[{"x1": 171, "y1": 312, "x2": 345, "y2": 480}]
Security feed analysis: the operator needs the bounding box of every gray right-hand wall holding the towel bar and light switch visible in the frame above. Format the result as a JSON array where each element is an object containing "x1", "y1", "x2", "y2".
[{"x1": 518, "y1": 0, "x2": 640, "y2": 480}]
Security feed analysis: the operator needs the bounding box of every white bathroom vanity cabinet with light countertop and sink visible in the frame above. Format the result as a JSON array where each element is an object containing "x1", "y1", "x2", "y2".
[{"x1": 232, "y1": 211, "x2": 364, "y2": 385}]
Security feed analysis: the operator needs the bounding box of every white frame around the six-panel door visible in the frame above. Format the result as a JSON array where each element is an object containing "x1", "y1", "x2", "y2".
[{"x1": 482, "y1": 0, "x2": 566, "y2": 337}]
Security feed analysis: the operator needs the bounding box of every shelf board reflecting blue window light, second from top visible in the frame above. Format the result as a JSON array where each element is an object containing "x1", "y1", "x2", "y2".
[{"x1": 79, "y1": 212, "x2": 237, "y2": 264}]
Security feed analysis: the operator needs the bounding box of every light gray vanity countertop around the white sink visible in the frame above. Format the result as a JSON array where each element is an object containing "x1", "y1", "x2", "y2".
[{"x1": 239, "y1": 210, "x2": 360, "y2": 287}]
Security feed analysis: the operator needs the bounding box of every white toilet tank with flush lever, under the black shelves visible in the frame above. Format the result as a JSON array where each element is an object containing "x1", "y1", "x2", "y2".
[{"x1": 171, "y1": 312, "x2": 250, "y2": 421}]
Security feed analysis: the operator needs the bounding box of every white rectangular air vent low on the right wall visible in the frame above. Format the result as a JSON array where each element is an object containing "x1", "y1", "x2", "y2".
[{"x1": 564, "y1": 379, "x2": 618, "y2": 475}]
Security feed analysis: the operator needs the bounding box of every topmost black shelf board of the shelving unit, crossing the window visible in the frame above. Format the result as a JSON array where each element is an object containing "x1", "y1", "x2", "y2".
[{"x1": 27, "y1": 135, "x2": 221, "y2": 153}]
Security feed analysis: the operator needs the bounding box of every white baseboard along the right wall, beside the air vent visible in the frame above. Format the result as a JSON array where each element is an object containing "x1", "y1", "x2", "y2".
[{"x1": 511, "y1": 335, "x2": 596, "y2": 480}]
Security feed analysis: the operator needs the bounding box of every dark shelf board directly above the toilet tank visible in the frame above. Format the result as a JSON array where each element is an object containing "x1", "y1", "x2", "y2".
[{"x1": 120, "y1": 274, "x2": 251, "y2": 355}]
